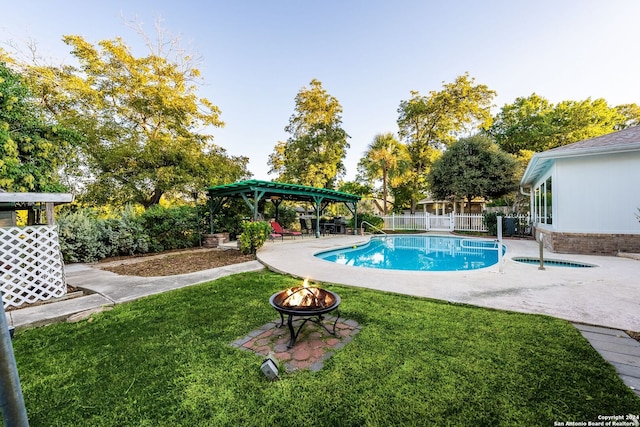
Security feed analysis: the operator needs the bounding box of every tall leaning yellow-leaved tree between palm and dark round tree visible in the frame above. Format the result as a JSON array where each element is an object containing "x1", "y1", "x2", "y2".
[{"x1": 398, "y1": 73, "x2": 496, "y2": 212}]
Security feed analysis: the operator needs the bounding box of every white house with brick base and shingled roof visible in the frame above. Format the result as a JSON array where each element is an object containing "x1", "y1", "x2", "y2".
[{"x1": 520, "y1": 126, "x2": 640, "y2": 255}]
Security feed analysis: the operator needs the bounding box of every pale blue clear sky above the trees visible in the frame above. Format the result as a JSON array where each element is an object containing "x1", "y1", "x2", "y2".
[{"x1": 0, "y1": 0, "x2": 640, "y2": 180}]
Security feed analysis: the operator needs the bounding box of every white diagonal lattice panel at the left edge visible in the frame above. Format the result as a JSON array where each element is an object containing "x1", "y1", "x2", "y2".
[{"x1": 0, "y1": 225, "x2": 67, "y2": 308}]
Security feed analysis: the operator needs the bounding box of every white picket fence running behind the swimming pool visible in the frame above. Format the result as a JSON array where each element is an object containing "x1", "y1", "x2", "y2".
[{"x1": 382, "y1": 212, "x2": 529, "y2": 232}]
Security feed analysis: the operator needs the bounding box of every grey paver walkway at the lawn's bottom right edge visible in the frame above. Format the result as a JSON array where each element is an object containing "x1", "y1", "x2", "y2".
[{"x1": 574, "y1": 323, "x2": 640, "y2": 397}]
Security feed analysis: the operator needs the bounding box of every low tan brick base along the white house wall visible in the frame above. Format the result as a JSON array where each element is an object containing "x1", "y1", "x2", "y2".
[{"x1": 535, "y1": 229, "x2": 640, "y2": 255}]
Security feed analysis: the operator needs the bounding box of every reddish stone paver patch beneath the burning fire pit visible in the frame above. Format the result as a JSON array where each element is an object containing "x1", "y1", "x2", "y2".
[{"x1": 231, "y1": 316, "x2": 361, "y2": 373}]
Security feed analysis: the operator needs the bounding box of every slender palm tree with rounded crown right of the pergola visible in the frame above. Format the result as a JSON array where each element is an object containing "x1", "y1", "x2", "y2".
[{"x1": 358, "y1": 133, "x2": 410, "y2": 215}]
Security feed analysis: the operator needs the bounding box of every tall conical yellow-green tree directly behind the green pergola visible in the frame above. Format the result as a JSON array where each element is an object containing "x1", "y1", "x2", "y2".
[{"x1": 268, "y1": 79, "x2": 349, "y2": 188}]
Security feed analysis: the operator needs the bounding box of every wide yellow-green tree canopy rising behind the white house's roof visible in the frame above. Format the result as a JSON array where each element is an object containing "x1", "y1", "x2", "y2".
[{"x1": 487, "y1": 93, "x2": 639, "y2": 154}]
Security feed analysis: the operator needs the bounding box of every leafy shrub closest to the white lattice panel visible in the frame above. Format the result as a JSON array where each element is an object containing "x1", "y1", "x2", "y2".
[{"x1": 58, "y1": 209, "x2": 109, "y2": 262}]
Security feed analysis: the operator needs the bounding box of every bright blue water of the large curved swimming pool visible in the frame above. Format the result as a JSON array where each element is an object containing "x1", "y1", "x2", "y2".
[{"x1": 316, "y1": 234, "x2": 506, "y2": 271}]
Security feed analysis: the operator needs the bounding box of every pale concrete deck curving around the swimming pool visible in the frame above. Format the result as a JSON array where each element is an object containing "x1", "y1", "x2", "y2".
[{"x1": 258, "y1": 235, "x2": 640, "y2": 331}]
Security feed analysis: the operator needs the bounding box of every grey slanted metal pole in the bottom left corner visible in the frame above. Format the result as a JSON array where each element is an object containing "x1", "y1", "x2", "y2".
[{"x1": 0, "y1": 304, "x2": 29, "y2": 427}]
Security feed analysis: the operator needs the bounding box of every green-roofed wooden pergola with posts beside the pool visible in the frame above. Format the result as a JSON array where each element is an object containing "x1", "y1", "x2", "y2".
[{"x1": 207, "y1": 180, "x2": 361, "y2": 237}]
